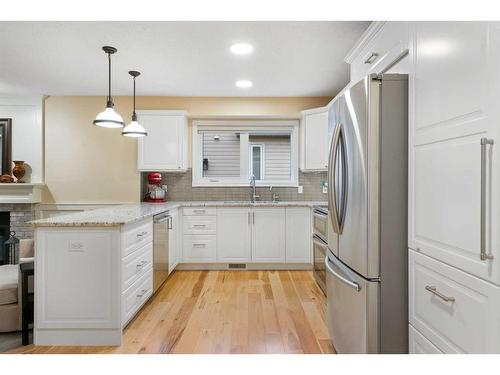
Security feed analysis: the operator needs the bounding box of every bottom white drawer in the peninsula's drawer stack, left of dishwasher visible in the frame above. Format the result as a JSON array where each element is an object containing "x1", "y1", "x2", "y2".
[{"x1": 122, "y1": 268, "x2": 153, "y2": 325}]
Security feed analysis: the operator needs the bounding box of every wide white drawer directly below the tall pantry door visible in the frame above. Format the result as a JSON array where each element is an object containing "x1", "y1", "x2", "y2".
[{"x1": 409, "y1": 251, "x2": 500, "y2": 353}]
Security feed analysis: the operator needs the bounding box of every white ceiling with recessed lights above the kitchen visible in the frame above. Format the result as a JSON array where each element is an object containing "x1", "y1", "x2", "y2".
[{"x1": 0, "y1": 22, "x2": 369, "y2": 96}]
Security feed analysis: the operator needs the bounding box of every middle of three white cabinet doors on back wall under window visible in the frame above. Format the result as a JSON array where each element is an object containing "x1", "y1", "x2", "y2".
[{"x1": 252, "y1": 207, "x2": 286, "y2": 262}]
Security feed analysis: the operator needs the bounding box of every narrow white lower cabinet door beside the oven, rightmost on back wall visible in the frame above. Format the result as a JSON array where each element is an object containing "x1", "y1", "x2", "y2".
[{"x1": 286, "y1": 207, "x2": 312, "y2": 263}]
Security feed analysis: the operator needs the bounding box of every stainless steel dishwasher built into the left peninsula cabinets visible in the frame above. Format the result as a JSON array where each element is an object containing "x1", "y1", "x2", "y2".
[{"x1": 153, "y1": 212, "x2": 172, "y2": 293}]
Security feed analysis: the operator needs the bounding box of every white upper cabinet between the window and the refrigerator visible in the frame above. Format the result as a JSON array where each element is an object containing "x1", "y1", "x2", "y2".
[{"x1": 300, "y1": 107, "x2": 328, "y2": 172}]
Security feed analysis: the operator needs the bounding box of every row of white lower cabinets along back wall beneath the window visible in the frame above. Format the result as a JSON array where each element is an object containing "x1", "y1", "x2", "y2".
[{"x1": 182, "y1": 206, "x2": 312, "y2": 264}]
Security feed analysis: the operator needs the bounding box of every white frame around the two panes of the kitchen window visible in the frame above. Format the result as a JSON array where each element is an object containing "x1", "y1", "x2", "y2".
[{"x1": 192, "y1": 119, "x2": 299, "y2": 187}]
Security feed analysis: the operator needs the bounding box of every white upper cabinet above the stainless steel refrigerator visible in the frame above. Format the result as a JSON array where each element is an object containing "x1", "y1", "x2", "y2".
[{"x1": 345, "y1": 22, "x2": 409, "y2": 82}]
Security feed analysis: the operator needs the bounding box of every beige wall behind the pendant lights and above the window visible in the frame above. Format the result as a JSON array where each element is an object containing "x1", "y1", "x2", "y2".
[{"x1": 42, "y1": 96, "x2": 331, "y2": 203}]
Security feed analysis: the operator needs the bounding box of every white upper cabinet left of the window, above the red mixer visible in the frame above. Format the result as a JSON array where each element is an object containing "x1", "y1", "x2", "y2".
[{"x1": 137, "y1": 110, "x2": 188, "y2": 172}]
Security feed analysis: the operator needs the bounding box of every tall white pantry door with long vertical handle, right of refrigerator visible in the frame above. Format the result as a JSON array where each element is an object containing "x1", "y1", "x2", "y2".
[{"x1": 408, "y1": 22, "x2": 500, "y2": 284}]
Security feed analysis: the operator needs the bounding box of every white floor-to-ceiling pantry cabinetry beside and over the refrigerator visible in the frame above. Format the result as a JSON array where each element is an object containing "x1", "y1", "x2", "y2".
[{"x1": 346, "y1": 22, "x2": 500, "y2": 353}]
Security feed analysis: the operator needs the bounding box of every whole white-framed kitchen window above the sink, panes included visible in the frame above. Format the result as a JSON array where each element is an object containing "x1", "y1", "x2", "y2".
[{"x1": 193, "y1": 120, "x2": 298, "y2": 186}]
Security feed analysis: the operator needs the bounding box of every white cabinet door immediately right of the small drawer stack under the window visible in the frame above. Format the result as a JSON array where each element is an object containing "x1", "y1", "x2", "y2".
[{"x1": 217, "y1": 207, "x2": 251, "y2": 262}]
